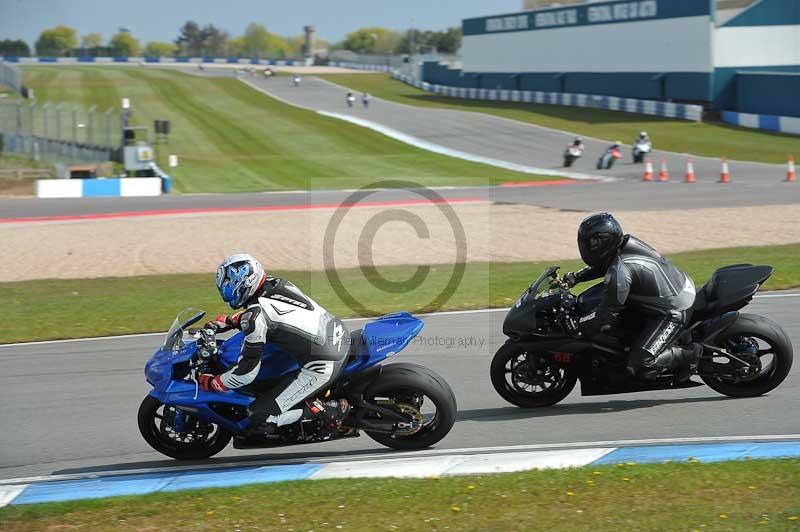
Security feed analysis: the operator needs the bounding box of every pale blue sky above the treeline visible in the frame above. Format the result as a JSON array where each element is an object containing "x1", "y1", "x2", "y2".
[{"x1": 0, "y1": 0, "x2": 522, "y2": 46}]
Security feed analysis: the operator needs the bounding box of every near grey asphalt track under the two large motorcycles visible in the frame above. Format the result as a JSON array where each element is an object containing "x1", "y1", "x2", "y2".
[{"x1": 0, "y1": 294, "x2": 800, "y2": 479}]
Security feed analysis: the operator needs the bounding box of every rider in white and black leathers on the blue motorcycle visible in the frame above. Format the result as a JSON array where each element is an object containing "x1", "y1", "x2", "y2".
[{"x1": 199, "y1": 254, "x2": 350, "y2": 434}]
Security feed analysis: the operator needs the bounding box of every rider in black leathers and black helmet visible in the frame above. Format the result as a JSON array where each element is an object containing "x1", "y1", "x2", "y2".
[{"x1": 564, "y1": 213, "x2": 702, "y2": 380}]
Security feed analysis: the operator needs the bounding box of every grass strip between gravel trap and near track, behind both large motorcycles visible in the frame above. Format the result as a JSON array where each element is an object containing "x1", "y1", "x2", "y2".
[{"x1": 0, "y1": 244, "x2": 800, "y2": 343}]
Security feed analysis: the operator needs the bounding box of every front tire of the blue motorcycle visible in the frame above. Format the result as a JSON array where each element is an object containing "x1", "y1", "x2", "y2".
[{"x1": 138, "y1": 395, "x2": 233, "y2": 460}]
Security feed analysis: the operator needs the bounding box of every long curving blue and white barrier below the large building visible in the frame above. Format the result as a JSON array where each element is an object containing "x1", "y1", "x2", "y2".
[{"x1": 390, "y1": 72, "x2": 703, "y2": 122}]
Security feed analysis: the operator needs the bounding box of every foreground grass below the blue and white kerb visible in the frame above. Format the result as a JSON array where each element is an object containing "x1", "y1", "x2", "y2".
[{"x1": 0, "y1": 460, "x2": 800, "y2": 531}]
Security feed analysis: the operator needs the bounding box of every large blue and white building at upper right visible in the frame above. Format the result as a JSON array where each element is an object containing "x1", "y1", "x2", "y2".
[{"x1": 419, "y1": 0, "x2": 800, "y2": 117}]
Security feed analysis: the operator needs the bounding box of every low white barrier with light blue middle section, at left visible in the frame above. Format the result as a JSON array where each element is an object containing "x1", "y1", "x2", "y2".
[{"x1": 36, "y1": 177, "x2": 164, "y2": 198}]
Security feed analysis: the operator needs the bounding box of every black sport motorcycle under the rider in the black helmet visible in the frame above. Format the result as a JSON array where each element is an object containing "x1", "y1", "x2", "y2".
[{"x1": 491, "y1": 264, "x2": 792, "y2": 407}]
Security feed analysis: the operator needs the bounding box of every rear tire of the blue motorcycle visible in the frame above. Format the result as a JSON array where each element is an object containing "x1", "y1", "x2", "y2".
[{"x1": 364, "y1": 363, "x2": 458, "y2": 451}]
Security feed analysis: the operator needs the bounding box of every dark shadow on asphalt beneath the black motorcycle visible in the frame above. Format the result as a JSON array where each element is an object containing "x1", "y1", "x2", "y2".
[{"x1": 456, "y1": 396, "x2": 748, "y2": 421}]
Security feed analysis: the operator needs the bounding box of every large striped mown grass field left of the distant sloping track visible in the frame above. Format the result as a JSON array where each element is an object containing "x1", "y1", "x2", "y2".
[{"x1": 24, "y1": 67, "x2": 556, "y2": 192}]
